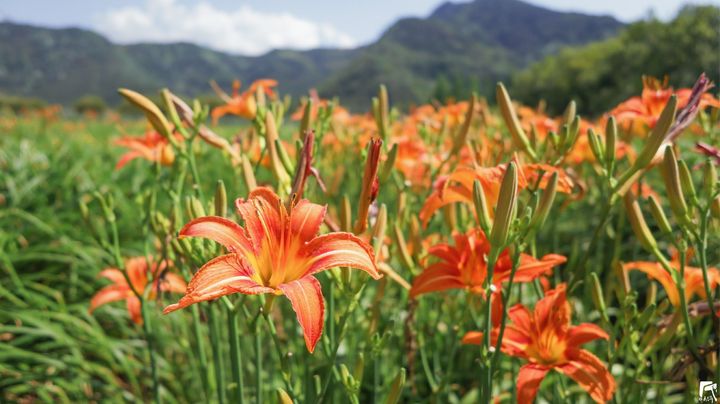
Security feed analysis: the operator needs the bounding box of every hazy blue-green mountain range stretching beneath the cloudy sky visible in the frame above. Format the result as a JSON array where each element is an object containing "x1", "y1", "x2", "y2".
[{"x1": 0, "y1": 0, "x2": 622, "y2": 110}]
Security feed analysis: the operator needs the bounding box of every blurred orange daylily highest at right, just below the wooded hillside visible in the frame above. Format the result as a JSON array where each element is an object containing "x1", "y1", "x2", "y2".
[{"x1": 609, "y1": 76, "x2": 720, "y2": 137}]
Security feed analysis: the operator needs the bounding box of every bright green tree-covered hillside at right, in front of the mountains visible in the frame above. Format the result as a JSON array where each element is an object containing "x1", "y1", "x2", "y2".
[{"x1": 512, "y1": 6, "x2": 720, "y2": 114}]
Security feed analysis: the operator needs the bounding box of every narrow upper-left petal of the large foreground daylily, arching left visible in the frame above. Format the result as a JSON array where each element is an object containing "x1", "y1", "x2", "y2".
[{"x1": 179, "y1": 216, "x2": 253, "y2": 254}]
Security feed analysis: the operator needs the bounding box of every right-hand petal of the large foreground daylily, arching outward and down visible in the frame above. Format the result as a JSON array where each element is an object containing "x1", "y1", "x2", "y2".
[{"x1": 298, "y1": 232, "x2": 382, "y2": 279}]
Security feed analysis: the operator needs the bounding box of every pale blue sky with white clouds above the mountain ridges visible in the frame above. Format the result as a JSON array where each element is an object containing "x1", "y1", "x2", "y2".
[{"x1": 0, "y1": 0, "x2": 720, "y2": 55}]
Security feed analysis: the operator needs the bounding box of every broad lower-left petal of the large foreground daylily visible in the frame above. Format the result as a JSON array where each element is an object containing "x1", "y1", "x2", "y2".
[{"x1": 163, "y1": 254, "x2": 273, "y2": 314}]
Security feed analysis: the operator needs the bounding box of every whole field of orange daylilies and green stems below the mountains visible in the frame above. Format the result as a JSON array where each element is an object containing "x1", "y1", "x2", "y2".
[{"x1": 0, "y1": 75, "x2": 720, "y2": 403}]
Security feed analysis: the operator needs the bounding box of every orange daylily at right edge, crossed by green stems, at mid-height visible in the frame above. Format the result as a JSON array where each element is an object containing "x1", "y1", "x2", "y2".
[{"x1": 623, "y1": 252, "x2": 720, "y2": 307}]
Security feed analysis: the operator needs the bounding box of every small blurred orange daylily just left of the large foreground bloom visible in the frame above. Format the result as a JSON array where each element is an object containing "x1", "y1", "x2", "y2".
[{"x1": 88, "y1": 257, "x2": 186, "y2": 324}]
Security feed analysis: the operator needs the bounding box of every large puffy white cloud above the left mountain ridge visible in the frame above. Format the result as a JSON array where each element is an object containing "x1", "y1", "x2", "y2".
[{"x1": 96, "y1": 0, "x2": 355, "y2": 55}]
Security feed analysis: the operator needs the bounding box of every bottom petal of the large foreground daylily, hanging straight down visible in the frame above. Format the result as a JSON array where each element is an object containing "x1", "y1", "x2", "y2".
[{"x1": 278, "y1": 276, "x2": 325, "y2": 352}]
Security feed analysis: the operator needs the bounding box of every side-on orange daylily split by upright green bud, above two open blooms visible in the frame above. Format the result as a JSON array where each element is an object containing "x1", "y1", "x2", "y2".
[{"x1": 420, "y1": 164, "x2": 573, "y2": 226}]
